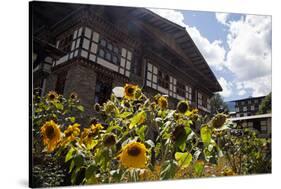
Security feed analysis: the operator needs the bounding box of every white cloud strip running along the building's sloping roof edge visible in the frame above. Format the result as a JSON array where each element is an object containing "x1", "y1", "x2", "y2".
[{"x1": 150, "y1": 9, "x2": 226, "y2": 70}]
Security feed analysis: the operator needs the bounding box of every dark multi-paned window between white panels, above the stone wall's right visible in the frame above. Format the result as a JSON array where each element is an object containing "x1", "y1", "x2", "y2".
[{"x1": 98, "y1": 38, "x2": 121, "y2": 65}]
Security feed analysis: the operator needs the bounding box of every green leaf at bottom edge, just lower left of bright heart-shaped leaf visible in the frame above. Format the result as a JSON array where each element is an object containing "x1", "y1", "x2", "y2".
[{"x1": 160, "y1": 160, "x2": 178, "y2": 180}]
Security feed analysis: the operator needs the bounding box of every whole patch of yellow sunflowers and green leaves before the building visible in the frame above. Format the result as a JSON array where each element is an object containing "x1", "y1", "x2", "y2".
[{"x1": 32, "y1": 84, "x2": 271, "y2": 187}]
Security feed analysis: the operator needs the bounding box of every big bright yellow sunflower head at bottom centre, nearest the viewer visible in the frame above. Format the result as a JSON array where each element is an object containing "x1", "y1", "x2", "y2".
[{"x1": 118, "y1": 142, "x2": 147, "y2": 168}]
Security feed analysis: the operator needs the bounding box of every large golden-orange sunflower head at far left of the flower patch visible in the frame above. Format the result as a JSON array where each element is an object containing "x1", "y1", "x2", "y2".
[{"x1": 41, "y1": 120, "x2": 61, "y2": 152}]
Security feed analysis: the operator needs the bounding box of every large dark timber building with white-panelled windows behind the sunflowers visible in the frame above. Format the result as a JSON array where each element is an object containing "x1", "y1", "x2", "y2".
[{"x1": 30, "y1": 2, "x2": 222, "y2": 114}]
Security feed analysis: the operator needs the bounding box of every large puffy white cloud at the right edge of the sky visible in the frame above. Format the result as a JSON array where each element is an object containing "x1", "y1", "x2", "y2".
[{"x1": 226, "y1": 15, "x2": 271, "y2": 96}]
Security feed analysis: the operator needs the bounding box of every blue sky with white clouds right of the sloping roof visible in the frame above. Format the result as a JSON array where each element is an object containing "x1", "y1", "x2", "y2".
[{"x1": 150, "y1": 9, "x2": 272, "y2": 101}]
